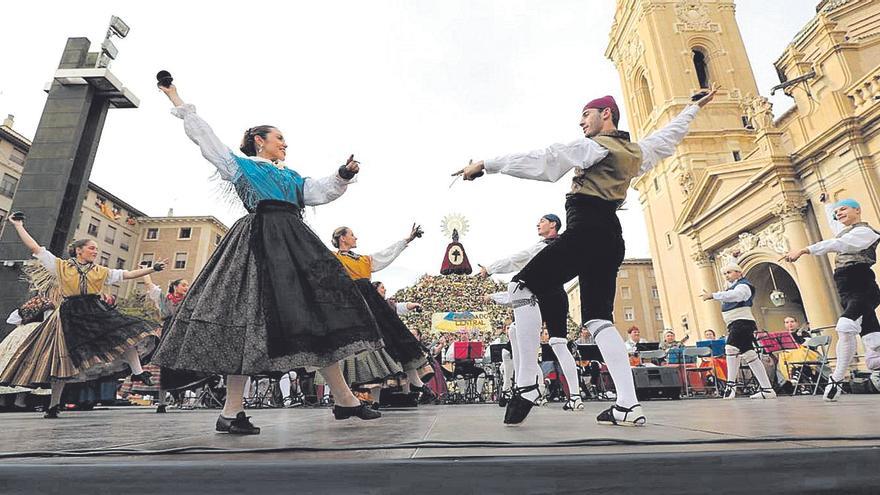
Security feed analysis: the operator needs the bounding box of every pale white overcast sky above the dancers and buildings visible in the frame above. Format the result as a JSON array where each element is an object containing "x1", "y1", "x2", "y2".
[{"x1": 0, "y1": 0, "x2": 817, "y2": 292}]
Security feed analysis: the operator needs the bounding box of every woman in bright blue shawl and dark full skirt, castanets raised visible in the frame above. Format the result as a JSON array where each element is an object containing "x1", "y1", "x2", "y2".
[{"x1": 153, "y1": 81, "x2": 381, "y2": 434}]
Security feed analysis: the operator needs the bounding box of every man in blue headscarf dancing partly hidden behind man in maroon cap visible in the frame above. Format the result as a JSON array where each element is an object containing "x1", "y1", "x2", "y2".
[{"x1": 479, "y1": 213, "x2": 584, "y2": 411}]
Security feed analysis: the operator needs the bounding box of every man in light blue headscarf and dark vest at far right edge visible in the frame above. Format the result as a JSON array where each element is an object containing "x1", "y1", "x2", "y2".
[{"x1": 783, "y1": 199, "x2": 880, "y2": 402}]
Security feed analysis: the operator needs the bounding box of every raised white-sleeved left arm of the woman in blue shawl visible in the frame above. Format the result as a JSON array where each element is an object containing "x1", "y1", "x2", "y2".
[{"x1": 159, "y1": 84, "x2": 241, "y2": 182}]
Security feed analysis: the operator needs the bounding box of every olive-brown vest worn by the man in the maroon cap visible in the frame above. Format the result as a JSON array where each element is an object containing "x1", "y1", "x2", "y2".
[{"x1": 571, "y1": 131, "x2": 642, "y2": 203}]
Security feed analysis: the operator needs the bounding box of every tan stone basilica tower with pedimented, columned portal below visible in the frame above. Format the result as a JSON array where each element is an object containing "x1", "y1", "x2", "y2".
[{"x1": 605, "y1": 0, "x2": 852, "y2": 337}]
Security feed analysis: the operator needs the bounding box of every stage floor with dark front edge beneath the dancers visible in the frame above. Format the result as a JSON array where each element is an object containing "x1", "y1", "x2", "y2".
[{"x1": 0, "y1": 395, "x2": 880, "y2": 495}]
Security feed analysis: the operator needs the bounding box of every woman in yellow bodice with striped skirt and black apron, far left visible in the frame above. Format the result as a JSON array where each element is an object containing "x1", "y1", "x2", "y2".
[{"x1": 0, "y1": 218, "x2": 164, "y2": 418}]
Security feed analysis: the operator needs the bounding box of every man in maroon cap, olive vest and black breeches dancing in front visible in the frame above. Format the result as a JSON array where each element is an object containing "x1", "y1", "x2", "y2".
[{"x1": 453, "y1": 88, "x2": 716, "y2": 426}]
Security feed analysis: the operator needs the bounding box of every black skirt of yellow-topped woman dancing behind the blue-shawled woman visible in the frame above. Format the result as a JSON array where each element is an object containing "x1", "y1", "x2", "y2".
[{"x1": 354, "y1": 278, "x2": 428, "y2": 371}]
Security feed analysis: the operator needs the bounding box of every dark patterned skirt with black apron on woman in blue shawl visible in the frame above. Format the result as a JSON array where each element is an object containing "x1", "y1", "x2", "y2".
[{"x1": 153, "y1": 201, "x2": 382, "y2": 375}]
